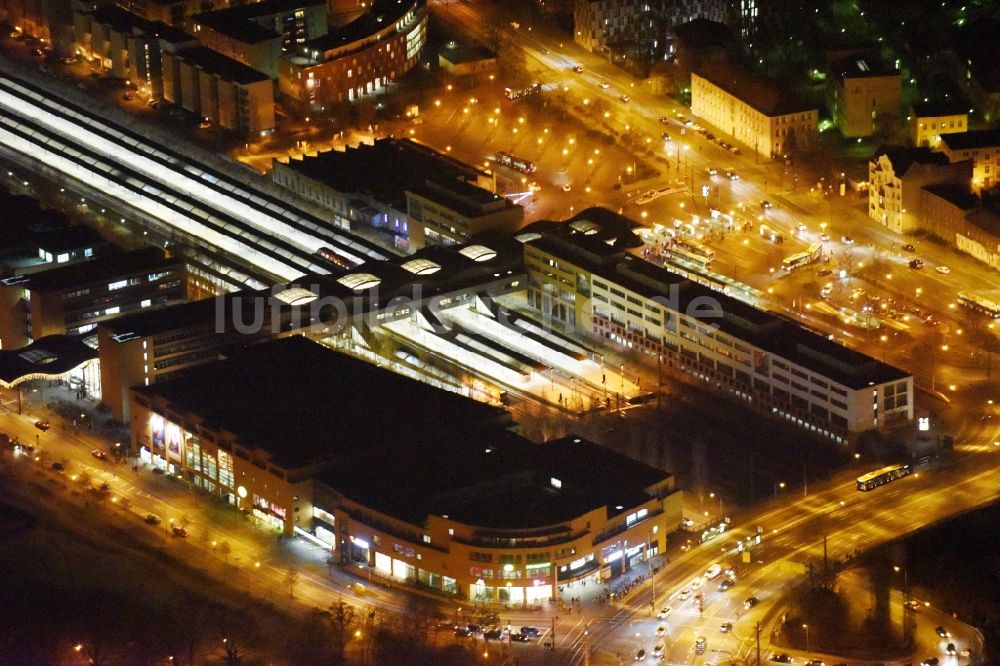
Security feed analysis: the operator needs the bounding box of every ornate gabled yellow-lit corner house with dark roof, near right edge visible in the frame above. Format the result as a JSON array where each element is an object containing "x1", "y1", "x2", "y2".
[{"x1": 868, "y1": 147, "x2": 972, "y2": 234}]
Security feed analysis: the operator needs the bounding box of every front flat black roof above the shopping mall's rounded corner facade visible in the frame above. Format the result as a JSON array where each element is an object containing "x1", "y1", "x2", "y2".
[{"x1": 318, "y1": 431, "x2": 670, "y2": 530}]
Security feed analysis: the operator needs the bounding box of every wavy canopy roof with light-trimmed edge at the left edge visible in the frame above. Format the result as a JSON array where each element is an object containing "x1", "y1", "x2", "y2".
[{"x1": 0, "y1": 335, "x2": 97, "y2": 388}]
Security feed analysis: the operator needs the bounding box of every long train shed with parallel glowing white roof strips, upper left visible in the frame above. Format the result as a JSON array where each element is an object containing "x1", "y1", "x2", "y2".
[{"x1": 0, "y1": 76, "x2": 386, "y2": 286}]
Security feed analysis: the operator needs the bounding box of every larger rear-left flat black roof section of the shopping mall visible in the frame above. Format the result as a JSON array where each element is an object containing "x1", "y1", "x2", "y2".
[{"x1": 134, "y1": 336, "x2": 507, "y2": 466}]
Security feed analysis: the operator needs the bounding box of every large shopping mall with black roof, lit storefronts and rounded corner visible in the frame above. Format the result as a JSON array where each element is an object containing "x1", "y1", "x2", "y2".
[{"x1": 131, "y1": 336, "x2": 681, "y2": 605}]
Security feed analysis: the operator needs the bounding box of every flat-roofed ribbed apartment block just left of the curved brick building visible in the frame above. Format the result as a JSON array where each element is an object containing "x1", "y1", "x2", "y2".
[{"x1": 162, "y1": 46, "x2": 274, "y2": 135}]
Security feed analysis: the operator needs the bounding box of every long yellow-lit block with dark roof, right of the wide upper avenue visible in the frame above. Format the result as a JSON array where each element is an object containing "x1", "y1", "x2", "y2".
[{"x1": 691, "y1": 62, "x2": 819, "y2": 158}]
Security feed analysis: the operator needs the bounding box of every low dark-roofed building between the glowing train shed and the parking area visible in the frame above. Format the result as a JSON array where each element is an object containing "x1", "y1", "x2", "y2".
[{"x1": 272, "y1": 139, "x2": 524, "y2": 251}]
